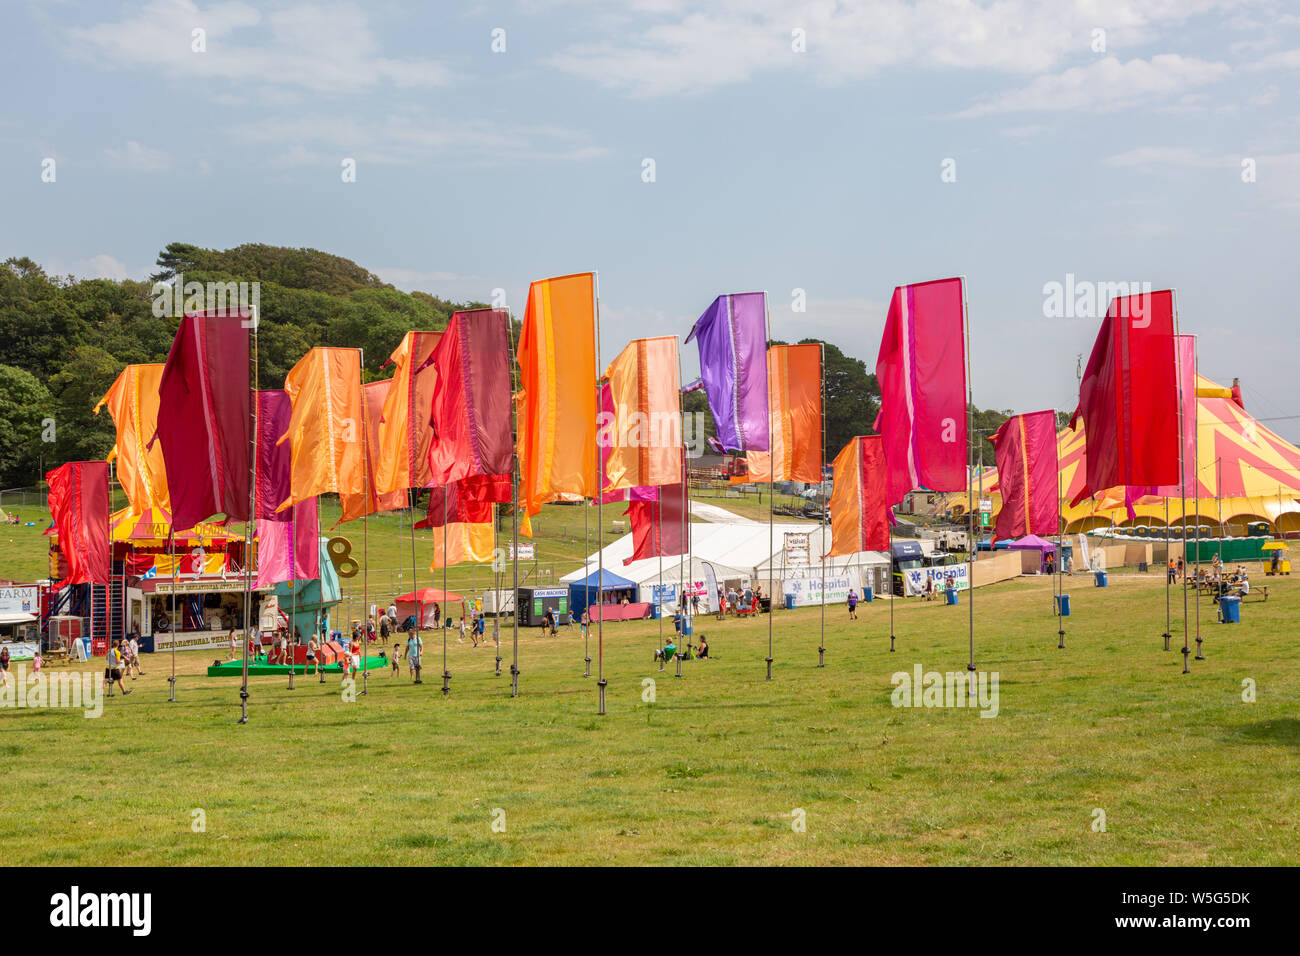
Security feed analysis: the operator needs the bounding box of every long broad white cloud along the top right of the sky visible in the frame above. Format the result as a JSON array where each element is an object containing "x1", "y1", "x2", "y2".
[{"x1": 549, "y1": 0, "x2": 1236, "y2": 98}]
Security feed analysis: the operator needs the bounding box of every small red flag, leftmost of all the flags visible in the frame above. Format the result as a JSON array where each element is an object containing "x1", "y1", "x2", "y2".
[{"x1": 46, "y1": 462, "x2": 112, "y2": 591}]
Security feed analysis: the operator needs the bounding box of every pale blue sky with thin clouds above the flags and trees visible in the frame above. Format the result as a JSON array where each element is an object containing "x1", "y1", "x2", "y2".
[{"x1": 0, "y1": 0, "x2": 1300, "y2": 440}]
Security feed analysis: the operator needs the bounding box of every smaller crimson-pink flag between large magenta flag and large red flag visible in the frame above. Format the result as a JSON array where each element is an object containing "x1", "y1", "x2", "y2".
[{"x1": 991, "y1": 411, "x2": 1061, "y2": 541}]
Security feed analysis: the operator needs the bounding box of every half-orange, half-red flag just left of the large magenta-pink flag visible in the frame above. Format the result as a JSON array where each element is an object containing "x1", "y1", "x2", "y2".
[{"x1": 826, "y1": 434, "x2": 891, "y2": 557}]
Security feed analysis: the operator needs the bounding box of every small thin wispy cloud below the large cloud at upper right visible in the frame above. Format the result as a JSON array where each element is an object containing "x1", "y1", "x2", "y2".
[{"x1": 958, "y1": 53, "x2": 1231, "y2": 117}]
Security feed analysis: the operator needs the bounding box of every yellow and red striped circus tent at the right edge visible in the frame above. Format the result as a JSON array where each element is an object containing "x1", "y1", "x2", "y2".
[{"x1": 941, "y1": 376, "x2": 1300, "y2": 533}]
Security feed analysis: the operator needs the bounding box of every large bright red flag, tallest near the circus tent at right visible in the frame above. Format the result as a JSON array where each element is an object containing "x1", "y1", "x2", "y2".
[{"x1": 1070, "y1": 290, "x2": 1179, "y2": 505}]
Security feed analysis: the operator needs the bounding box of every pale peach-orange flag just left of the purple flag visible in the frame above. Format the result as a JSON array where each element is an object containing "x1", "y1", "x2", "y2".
[{"x1": 601, "y1": 336, "x2": 681, "y2": 492}]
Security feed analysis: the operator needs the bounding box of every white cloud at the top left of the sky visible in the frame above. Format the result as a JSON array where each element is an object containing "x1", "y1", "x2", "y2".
[{"x1": 70, "y1": 0, "x2": 451, "y2": 92}]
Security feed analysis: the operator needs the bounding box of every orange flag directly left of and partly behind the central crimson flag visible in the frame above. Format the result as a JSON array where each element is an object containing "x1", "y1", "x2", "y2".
[{"x1": 374, "y1": 332, "x2": 442, "y2": 494}]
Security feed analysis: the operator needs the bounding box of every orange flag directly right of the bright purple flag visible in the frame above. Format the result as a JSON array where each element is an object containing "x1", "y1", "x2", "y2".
[{"x1": 745, "y1": 342, "x2": 823, "y2": 483}]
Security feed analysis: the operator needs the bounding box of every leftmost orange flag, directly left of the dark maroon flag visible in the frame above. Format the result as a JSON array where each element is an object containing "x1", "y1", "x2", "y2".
[{"x1": 95, "y1": 364, "x2": 172, "y2": 515}]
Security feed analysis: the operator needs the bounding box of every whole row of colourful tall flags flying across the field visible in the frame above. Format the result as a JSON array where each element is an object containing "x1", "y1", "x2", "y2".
[{"x1": 47, "y1": 272, "x2": 1195, "y2": 595}]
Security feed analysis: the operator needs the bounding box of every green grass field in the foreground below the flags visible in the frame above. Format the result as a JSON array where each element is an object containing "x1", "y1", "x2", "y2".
[{"x1": 0, "y1": 561, "x2": 1300, "y2": 865}]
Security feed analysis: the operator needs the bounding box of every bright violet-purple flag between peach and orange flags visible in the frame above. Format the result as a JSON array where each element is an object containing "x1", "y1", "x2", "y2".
[{"x1": 686, "y1": 293, "x2": 768, "y2": 454}]
